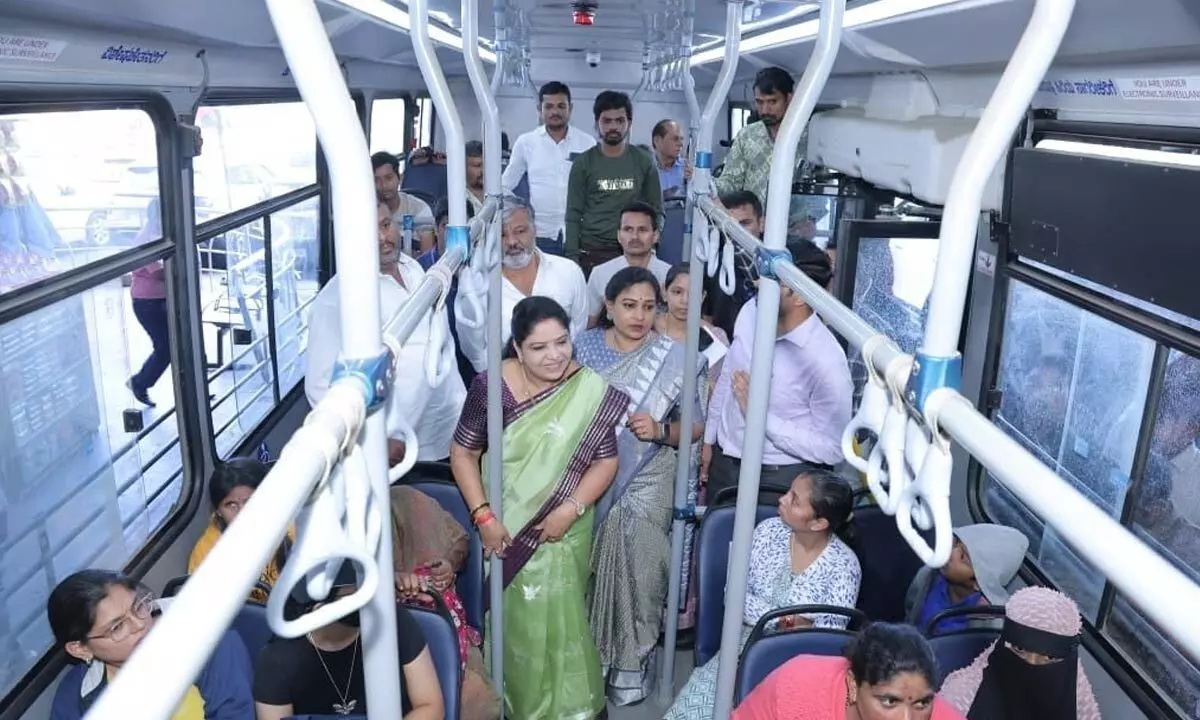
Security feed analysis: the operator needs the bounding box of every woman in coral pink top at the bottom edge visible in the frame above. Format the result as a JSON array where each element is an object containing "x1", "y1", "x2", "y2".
[{"x1": 733, "y1": 623, "x2": 962, "y2": 720}]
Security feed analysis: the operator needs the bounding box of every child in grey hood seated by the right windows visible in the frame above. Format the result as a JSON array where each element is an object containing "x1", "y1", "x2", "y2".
[{"x1": 905, "y1": 523, "x2": 1030, "y2": 632}]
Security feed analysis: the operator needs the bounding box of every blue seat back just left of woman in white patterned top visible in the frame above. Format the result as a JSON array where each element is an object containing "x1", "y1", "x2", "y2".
[{"x1": 692, "y1": 505, "x2": 778, "y2": 667}]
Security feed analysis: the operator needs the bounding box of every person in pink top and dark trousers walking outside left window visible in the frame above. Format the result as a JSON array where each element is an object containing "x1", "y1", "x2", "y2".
[{"x1": 126, "y1": 198, "x2": 170, "y2": 407}]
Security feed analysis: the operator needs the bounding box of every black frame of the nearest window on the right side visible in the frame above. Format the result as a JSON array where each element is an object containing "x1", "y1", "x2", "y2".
[{"x1": 966, "y1": 120, "x2": 1200, "y2": 720}]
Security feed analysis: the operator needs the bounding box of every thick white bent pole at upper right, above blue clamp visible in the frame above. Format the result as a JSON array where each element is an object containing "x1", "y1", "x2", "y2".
[{"x1": 918, "y1": 0, "x2": 1075, "y2": 362}]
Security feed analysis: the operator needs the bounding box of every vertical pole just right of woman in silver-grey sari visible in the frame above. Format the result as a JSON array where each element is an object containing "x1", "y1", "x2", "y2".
[{"x1": 659, "y1": 0, "x2": 742, "y2": 704}]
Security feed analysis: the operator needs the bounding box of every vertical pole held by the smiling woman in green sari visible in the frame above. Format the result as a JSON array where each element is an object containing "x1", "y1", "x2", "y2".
[{"x1": 462, "y1": 0, "x2": 504, "y2": 700}]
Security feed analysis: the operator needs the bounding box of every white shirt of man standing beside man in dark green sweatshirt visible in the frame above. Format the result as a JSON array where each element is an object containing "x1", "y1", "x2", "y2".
[{"x1": 504, "y1": 125, "x2": 596, "y2": 239}]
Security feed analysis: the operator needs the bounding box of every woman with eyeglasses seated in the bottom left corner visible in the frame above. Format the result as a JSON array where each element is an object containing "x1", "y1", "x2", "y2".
[{"x1": 46, "y1": 570, "x2": 254, "y2": 720}]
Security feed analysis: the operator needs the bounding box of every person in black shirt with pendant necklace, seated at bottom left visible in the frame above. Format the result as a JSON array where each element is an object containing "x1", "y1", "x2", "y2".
[{"x1": 254, "y1": 565, "x2": 445, "y2": 720}]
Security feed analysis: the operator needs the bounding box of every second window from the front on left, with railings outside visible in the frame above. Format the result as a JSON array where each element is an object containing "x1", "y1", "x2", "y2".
[{"x1": 196, "y1": 103, "x2": 320, "y2": 457}]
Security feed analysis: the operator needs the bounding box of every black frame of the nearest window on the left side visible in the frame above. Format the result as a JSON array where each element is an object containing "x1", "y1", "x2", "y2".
[{"x1": 0, "y1": 89, "x2": 209, "y2": 720}]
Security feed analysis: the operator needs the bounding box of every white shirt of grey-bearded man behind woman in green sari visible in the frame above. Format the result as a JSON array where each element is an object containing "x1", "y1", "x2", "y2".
[{"x1": 455, "y1": 251, "x2": 588, "y2": 372}]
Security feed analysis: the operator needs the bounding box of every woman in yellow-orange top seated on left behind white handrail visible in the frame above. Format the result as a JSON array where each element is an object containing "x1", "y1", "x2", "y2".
[{"x1": 187, "y1": 457, "x2": 295, "y2": 605}]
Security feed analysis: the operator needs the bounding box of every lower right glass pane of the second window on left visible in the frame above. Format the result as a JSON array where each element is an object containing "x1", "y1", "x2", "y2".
[{"x1": 271, "y1": 198, "x2": 320, "y2": 395}]
